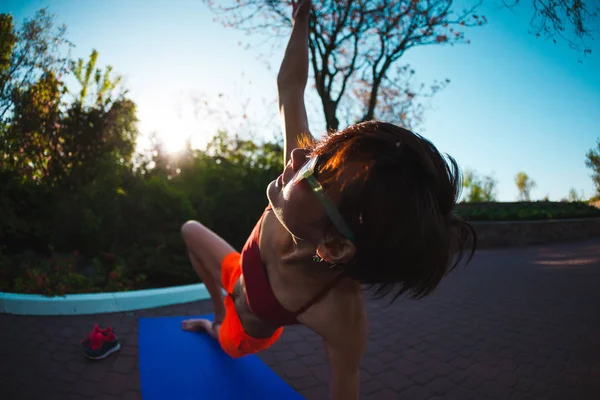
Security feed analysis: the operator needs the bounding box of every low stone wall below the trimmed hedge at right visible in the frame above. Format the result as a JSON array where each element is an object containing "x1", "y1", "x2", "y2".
[{"x1": 471, "y1": 218, "x2": 600, "y2": 248}]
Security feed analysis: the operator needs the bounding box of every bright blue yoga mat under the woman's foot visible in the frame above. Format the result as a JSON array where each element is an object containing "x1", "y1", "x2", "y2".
[{"x1": 138, "y1": 315, "x2": 302, "y2": 400}]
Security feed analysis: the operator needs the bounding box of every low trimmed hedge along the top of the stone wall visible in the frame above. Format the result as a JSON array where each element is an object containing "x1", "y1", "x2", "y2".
[{"x1": 456, "y1": 201, "x2": 600, "y2": 221}]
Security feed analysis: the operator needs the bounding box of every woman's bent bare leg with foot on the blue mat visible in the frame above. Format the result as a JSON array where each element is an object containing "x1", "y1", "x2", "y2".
[{"x1": 181, "y1": 221, "x2": 235, "y2": 338}]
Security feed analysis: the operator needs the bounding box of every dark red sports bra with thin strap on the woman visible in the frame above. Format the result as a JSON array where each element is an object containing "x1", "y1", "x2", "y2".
[{"x1": 240, "y1": 207, "x2": 343, "y2": 326}]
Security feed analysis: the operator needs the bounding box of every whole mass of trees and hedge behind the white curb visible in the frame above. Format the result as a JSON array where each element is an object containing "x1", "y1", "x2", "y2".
[{"x1": 0, "y1": 8, "x2": 283, "y2": 295}]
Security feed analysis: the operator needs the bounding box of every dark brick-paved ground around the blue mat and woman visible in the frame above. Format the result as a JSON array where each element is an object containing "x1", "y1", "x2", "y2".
[{"x1": 0, "y1": 240, "x2": 600, "y2": 400}]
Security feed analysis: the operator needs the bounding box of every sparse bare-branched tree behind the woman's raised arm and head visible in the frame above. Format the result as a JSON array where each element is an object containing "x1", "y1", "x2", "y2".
[{"x1": 204, "y1": 0, "x2": 486, "y2": 129}]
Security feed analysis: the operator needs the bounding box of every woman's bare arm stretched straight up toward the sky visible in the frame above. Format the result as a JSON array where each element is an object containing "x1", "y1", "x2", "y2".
[{"x1": 277, "y1": 0, "x2": 312, "y2": 165}]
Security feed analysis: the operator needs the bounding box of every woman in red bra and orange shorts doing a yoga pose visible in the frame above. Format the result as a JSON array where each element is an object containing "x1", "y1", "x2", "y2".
[{"x1": 182, "y1": 0, "x2": 475, "y2": 400}]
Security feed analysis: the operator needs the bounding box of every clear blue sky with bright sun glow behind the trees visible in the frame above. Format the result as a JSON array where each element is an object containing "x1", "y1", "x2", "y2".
[{"x1": 0, "y1": 0, "x2": 600, "y2": 201}]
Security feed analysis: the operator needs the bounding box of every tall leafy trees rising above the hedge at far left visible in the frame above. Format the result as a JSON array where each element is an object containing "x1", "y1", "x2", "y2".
[{"x1": 0, "y1": 17, "x2": 137, "y2": 188}]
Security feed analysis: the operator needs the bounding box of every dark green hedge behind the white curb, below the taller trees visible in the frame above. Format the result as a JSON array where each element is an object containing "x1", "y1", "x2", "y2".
[{"x1": 0, "y1": 133, "x2": 283, "y2": 295}]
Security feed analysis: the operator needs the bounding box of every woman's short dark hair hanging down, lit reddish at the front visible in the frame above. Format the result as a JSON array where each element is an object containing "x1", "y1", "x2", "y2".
[{"x1": 311, "y1": 121, "x2": 477, "y2": 301}]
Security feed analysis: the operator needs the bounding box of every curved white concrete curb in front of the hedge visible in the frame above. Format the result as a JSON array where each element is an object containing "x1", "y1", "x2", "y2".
[{"x1": 0, "y1": 283, "x2": 210, "y2": 315}]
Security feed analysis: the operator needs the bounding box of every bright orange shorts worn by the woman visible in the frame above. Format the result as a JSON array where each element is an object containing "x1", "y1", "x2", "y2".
[{"x1": 219, "y1": 252, "x2": 283, "y2": 358}]
